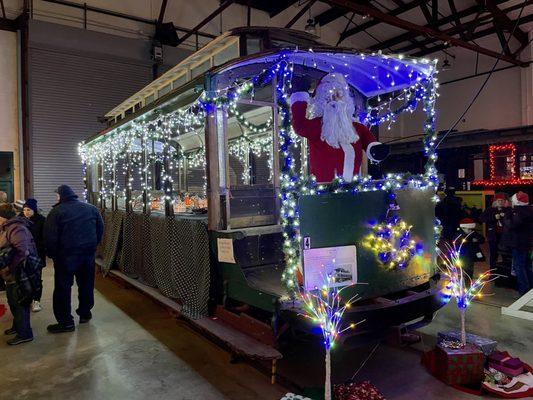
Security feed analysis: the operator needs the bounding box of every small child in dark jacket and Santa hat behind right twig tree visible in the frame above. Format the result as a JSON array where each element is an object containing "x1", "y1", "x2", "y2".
[{"x1": 456, "y1": 218, "x2": 485, "y2": 278}]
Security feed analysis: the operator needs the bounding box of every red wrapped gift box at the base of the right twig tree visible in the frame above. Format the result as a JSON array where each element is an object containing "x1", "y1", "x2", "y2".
[{"x1": 433, "y1": 344, "x2": 485, "y2": 385}]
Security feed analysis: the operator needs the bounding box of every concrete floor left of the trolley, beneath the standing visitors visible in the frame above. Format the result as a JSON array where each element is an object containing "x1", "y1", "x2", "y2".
[{"x1": 0, "y1": 267, "x2": 286, "y2": 400}]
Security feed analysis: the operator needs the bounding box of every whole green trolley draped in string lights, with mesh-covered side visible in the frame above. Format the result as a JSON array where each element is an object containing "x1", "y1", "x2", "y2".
[{"x1": 80, "y1": 28, "x2": 442, "y2": 341}]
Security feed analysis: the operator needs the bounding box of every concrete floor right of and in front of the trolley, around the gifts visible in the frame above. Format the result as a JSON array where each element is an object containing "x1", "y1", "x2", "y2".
[{"x1": 274, "y1": 296, "x2": 533, "y2": 400}]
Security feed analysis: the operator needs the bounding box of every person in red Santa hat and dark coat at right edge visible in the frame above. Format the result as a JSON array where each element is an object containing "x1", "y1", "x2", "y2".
[{"x1": 502, "y1": 192, "x2": 533, "y2": 296}]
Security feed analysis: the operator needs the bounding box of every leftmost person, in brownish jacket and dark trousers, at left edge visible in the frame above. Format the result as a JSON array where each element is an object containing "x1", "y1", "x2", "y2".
[{"x1": 0, "y1": 208, "x2": 37, "y2": 345}]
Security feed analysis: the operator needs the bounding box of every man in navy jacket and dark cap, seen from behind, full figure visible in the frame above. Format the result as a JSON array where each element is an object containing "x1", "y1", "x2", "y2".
[{"x1": 44, "y1": 185, "x2": 104, "y2": 333}]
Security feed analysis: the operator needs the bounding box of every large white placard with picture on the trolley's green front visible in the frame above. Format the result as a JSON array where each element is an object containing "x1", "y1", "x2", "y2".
[{"x1": 303, "y1": 246, "x2": 357, "y2": 290}]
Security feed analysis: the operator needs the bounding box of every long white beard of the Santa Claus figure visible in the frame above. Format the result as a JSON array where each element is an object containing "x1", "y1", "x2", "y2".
[{"x1": 320, "y1": 101, "x2": 359, "y2": 149}]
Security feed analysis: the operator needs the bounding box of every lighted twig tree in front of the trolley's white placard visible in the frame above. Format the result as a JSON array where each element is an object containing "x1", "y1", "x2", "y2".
[{"x1": 300, "y1": 275, "x2": 363, "y2": 400}]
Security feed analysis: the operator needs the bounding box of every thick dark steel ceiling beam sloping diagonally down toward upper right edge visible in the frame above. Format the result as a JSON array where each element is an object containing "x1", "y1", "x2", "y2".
[{"x1": 329, "y1": 0, "x2": 525, "y2": 66}]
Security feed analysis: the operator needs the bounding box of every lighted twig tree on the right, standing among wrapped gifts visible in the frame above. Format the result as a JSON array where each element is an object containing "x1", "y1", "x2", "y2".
[{"x1": 438, "y1": 236, "x2": 501, "y2": 346}]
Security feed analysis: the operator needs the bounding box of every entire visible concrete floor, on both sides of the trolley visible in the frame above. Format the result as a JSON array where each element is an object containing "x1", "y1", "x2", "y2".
[{"x1": 0, "y1": 268, "x2": 533, "y2": 400}]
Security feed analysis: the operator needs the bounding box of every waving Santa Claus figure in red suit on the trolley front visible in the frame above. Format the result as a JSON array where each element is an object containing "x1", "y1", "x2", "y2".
[{"x1": 290, "y1": 73, "x2": 388, "y2": 182}]
